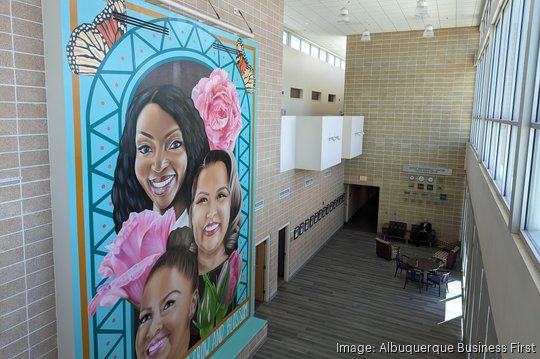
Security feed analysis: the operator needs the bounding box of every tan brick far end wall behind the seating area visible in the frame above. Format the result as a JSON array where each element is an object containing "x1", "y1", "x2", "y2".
[{"x1": 344, "y1": 27, "x2": 478, "y2": 241}]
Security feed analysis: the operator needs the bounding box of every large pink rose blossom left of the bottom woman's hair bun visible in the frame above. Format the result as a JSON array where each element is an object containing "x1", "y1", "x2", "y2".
[{"x1": 88, "y1": 208, "x2": 176, "y2": 315}]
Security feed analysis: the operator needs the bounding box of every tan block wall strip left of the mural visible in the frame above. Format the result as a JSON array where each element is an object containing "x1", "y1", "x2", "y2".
[{"x1": 0, "y1": 0, "x2": 57, "y2": 358}]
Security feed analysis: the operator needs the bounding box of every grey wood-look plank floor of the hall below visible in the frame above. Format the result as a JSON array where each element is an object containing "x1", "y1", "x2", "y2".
[{"x1": 255, "y1": 229, "x2": 465, "y2": 358}]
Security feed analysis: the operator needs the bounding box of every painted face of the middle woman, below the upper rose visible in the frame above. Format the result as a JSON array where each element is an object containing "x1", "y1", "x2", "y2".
[{"x1": 191, "y1": 162, "x2": 231, "y2": 255}]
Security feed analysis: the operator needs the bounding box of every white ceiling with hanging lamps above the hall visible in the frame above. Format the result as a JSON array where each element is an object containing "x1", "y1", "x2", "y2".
[{"x1": 285, "y1": 0, "x2": 484, "y2": 58}]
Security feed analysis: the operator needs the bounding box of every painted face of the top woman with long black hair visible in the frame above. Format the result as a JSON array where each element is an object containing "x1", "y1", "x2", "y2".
[{"x1": 135, "y1": 103, "x2": 188, "y2": 213}]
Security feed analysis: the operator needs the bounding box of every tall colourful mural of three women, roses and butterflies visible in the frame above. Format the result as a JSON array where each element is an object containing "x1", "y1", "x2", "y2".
[{"x1": 62, "y1": 0, "x2": 257, "y2": 358}]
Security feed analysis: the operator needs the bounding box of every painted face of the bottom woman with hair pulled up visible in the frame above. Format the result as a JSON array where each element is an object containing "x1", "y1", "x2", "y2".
[{"x1": 135, "y1": 267, "x2": 197, "y2": 359}]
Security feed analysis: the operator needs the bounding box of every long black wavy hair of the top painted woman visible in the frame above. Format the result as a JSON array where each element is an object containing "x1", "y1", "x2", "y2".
[{"x1": 111, "y1": 85, "x2": 210, "y2": 233}]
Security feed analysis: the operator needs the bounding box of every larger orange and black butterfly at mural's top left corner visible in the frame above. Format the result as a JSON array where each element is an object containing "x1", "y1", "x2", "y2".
[{"x1": 66, "y1": 0, "x2": 126, "y2": 76}]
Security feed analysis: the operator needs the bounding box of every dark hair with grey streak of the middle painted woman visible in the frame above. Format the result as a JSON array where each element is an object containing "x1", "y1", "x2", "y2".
[{"x1": 189, "y1": 150, "x2": 242, "y2": 255}]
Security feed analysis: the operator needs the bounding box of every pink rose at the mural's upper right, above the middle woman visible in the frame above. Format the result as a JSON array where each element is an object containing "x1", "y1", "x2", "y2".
[{"x1": 191, "y1": 68, "x2": 242, "y2": 150}]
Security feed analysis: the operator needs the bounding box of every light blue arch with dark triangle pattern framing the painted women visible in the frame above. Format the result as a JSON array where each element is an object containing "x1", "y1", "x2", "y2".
[{"x1": 83, "y1": 19, "x2": 254, "y2": 358}]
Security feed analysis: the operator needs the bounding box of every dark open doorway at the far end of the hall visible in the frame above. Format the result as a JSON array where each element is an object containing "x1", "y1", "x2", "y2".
[{"x1": 344, "y1": 185, "x2": 380, "y2": 233}]
